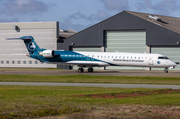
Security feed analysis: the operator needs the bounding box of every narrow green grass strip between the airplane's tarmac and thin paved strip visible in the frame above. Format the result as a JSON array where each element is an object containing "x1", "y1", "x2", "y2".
[{"x1": 0, "y1": 75, "x2": 180, "y2": 85}]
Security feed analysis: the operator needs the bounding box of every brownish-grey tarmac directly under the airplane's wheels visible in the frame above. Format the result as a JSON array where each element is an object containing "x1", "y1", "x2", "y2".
[{"x1": 0, "y1": 68, "x2": 180, "y2": 77}]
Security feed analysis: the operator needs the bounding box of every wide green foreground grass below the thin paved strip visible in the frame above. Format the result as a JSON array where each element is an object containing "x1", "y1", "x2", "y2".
[{"x1": 0, "y1": 86, "x2": 180, "y2": 119}]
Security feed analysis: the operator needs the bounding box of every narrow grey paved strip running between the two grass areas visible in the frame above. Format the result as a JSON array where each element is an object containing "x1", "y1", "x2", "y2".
[{"x1": 0, "y1": 82, "x2": 180, "y2": 89}]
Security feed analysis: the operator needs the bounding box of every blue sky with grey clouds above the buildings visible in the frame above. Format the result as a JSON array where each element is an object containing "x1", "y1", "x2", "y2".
[{"x1": 0, "y1": 0, "x2": 180, "y2": 31}]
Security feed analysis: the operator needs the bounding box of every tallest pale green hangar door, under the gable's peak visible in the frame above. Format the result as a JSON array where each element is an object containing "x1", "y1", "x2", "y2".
[{"x1": 105, "y1": 30, "x2": 146, "y2": 69}]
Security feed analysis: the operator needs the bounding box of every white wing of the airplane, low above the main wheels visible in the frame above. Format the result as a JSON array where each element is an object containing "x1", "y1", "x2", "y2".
[{"x1": 55, "y1": 61, "x2": 109, "y2": 67}]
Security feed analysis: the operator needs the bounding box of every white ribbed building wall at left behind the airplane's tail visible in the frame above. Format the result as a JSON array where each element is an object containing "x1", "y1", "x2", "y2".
[{"x1": 0, "y1": 22, "x2": 59, "y2": 68}]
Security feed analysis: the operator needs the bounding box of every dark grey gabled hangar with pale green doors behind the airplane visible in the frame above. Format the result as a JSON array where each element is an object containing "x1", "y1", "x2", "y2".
[{"x1": 57, "y1": 11, "x2": 180, "y2": 70}]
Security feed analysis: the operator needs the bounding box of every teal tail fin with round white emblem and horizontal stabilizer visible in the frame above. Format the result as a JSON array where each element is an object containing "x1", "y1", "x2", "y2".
[{"x1": 7, "y1": 36, "x2": 41, "y2": 54}]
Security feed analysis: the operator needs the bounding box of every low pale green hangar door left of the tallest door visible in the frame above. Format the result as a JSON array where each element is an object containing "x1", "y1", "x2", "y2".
[{"x1": 72, "y1": 47, "x2": 101, "y2": 69}]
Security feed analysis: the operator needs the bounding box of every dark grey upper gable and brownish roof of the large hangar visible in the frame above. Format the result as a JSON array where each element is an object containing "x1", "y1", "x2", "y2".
[{"x1": 65, "y1": 11, "x2": 180, "y2": 47}]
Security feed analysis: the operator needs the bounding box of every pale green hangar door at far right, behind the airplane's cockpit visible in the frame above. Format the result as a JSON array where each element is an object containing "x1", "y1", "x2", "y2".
[{"x1": 151, "y1": 47, "x2": 180, "y2": 70}]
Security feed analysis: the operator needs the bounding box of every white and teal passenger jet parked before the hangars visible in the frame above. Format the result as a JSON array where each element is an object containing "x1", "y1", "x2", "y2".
[{"x1": 7, "y1": 36, "x2": 178, "y2": 73}]
